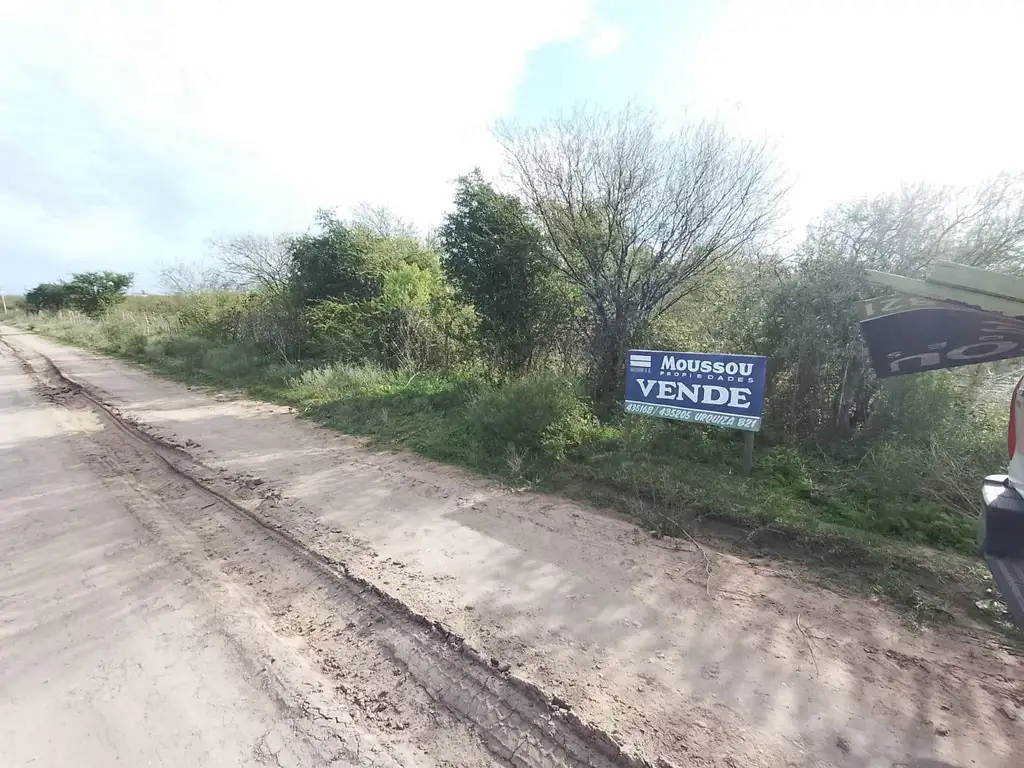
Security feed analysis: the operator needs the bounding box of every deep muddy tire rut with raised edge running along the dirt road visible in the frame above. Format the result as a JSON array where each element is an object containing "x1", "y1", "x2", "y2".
[{"x1": 3, "y1": 341, "x2": 650, "y2": 768}]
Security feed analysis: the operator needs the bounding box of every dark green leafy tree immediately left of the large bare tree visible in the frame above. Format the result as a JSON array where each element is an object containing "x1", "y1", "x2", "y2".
[{"x1": 438, "y1": 171, "x2": 567, "y2": 375}]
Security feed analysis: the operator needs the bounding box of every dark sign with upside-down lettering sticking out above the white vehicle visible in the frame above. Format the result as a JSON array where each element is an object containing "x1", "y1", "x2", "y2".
[{"x1": 858, "y1": 296, "x2": 1024, "y2": 379}]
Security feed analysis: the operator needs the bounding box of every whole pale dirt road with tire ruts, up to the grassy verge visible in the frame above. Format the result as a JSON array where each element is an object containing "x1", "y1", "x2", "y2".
[{"x1": 0, "y1": 329, "x2": 1024, "y2": 768}]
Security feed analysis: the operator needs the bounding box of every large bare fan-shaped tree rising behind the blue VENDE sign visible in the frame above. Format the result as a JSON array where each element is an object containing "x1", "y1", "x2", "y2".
[{"x1": 496, "y1": 106, "x2": 783, "y2": 404}]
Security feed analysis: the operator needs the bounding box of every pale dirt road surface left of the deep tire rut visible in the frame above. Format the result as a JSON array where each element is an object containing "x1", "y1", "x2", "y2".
[{"x1": 0, "y1": 335, "x2": 496, "y2": 768}]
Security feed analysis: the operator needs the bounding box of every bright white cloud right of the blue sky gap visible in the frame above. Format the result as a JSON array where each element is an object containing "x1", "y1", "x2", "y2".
[{"x1": 662, "y1": 0, "x2": 1024, "y2": 237}]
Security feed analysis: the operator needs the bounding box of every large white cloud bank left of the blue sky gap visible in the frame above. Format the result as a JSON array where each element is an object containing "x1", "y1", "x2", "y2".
[{"x1": 0, "y1": 0, "x2": 607, "y2": 288}]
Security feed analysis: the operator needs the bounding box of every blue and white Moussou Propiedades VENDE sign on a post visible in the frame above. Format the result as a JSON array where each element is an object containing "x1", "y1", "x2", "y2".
[{"x1": 626, "y1": 349, "x2": 767, "y2": 432}]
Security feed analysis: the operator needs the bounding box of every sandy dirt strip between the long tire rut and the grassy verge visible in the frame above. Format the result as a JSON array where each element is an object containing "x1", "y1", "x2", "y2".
[{"x1": 6, "y1": 327, "x2": 1024, "y2": 768}]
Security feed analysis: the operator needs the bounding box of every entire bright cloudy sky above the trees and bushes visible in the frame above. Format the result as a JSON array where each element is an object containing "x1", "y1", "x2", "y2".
[{"x1": 0, "y1": 0, "x2": 1024, "y2": 292}]
